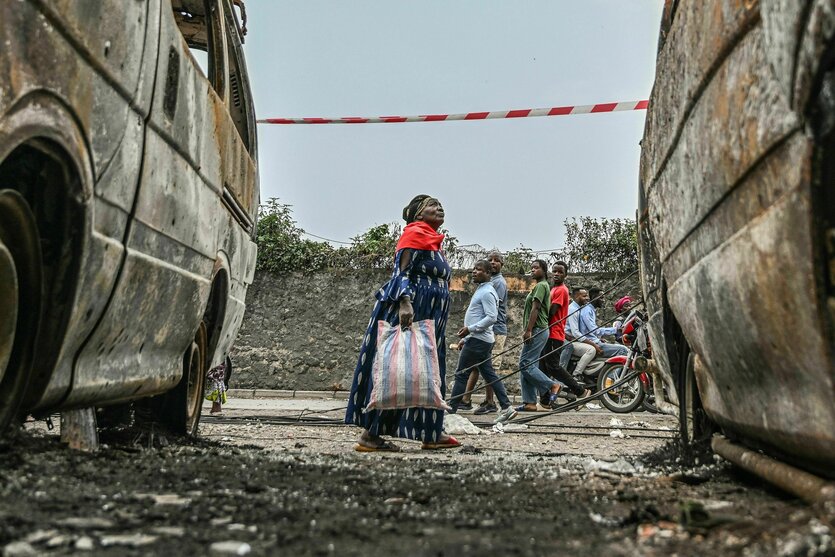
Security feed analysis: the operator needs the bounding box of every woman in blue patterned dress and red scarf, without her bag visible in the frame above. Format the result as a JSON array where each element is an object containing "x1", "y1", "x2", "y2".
[{"x1": 345, "y1": 195, "x2": 460, "y2": 452}]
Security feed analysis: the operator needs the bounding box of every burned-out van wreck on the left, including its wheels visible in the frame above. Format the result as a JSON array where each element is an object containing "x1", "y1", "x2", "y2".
[{"x1": 0, "y1": 0, "x2": 259, "y2": 433}]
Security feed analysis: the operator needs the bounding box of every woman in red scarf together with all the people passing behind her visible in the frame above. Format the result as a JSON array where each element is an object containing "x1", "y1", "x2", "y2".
[{"x1": 345, "y1": 195, "x2": 626, "y2": 452}]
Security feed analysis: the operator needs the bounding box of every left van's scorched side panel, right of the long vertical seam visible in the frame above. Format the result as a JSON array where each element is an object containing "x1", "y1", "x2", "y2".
[{"x1": 69, "y1": 0, "x2": 258, "y2": 404}]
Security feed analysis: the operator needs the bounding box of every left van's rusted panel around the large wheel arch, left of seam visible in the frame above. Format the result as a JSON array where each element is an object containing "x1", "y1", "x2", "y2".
[{"x1": 0, "y1": 0, "x2": 159, "y2": 403}]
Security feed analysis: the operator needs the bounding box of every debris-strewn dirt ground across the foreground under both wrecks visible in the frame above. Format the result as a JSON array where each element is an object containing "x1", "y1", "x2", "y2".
[{"x1": 0, "y1": 394, "x2": 835, "y2": 556}]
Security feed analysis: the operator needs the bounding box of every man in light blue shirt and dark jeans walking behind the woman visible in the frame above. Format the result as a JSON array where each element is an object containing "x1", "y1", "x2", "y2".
[{"x1": 449, "y1": 259, "x2": 516, "y2": 422}]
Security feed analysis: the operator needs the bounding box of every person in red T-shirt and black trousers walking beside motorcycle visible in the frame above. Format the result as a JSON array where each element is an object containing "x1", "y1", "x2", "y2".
[{"x1": 542, "y1": 261, "x2": 591, "y2": 404}]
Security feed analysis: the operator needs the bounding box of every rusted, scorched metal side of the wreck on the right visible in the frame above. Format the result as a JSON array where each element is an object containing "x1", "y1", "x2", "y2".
[{"x1": 639, "y1": 0, "x2": 835, "y2": 475}]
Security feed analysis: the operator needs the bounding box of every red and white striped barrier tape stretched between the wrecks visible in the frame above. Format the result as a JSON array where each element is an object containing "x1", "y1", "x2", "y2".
[{"x1": 257, "y1": 101, "x2": 649, "y2": 124}]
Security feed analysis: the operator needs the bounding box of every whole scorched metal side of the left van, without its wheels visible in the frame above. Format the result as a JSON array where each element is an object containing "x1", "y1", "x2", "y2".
[{"x1": 0, "y1": 0, "x2": 258, "y2": 408}]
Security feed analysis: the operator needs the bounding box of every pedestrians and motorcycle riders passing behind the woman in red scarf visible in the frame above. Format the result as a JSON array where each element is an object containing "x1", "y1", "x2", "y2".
[{"x1": 450, "y1": 252, "x2": 631, "y2": 416}]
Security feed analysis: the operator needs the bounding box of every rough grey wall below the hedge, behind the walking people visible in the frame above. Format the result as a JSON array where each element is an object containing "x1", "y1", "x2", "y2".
[{"x1": 230, "y1": 270, "x2": 638, "y2": 390}]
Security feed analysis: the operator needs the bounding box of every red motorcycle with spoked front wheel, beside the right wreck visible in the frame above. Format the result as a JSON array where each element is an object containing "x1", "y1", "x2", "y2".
[{"x1": 596, "y1": 311, "x2": 654, "y2": 414}]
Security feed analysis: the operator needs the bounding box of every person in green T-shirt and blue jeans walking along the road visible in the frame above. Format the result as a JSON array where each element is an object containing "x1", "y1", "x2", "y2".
[{"x1": 516, "y1": 259, "x2": 560, "y2": 412}]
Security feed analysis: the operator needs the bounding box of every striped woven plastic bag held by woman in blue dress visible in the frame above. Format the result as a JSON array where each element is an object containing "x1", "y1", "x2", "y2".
[{"x1": 365, "y1": 319, "x2": 450, "y2": 412}]
